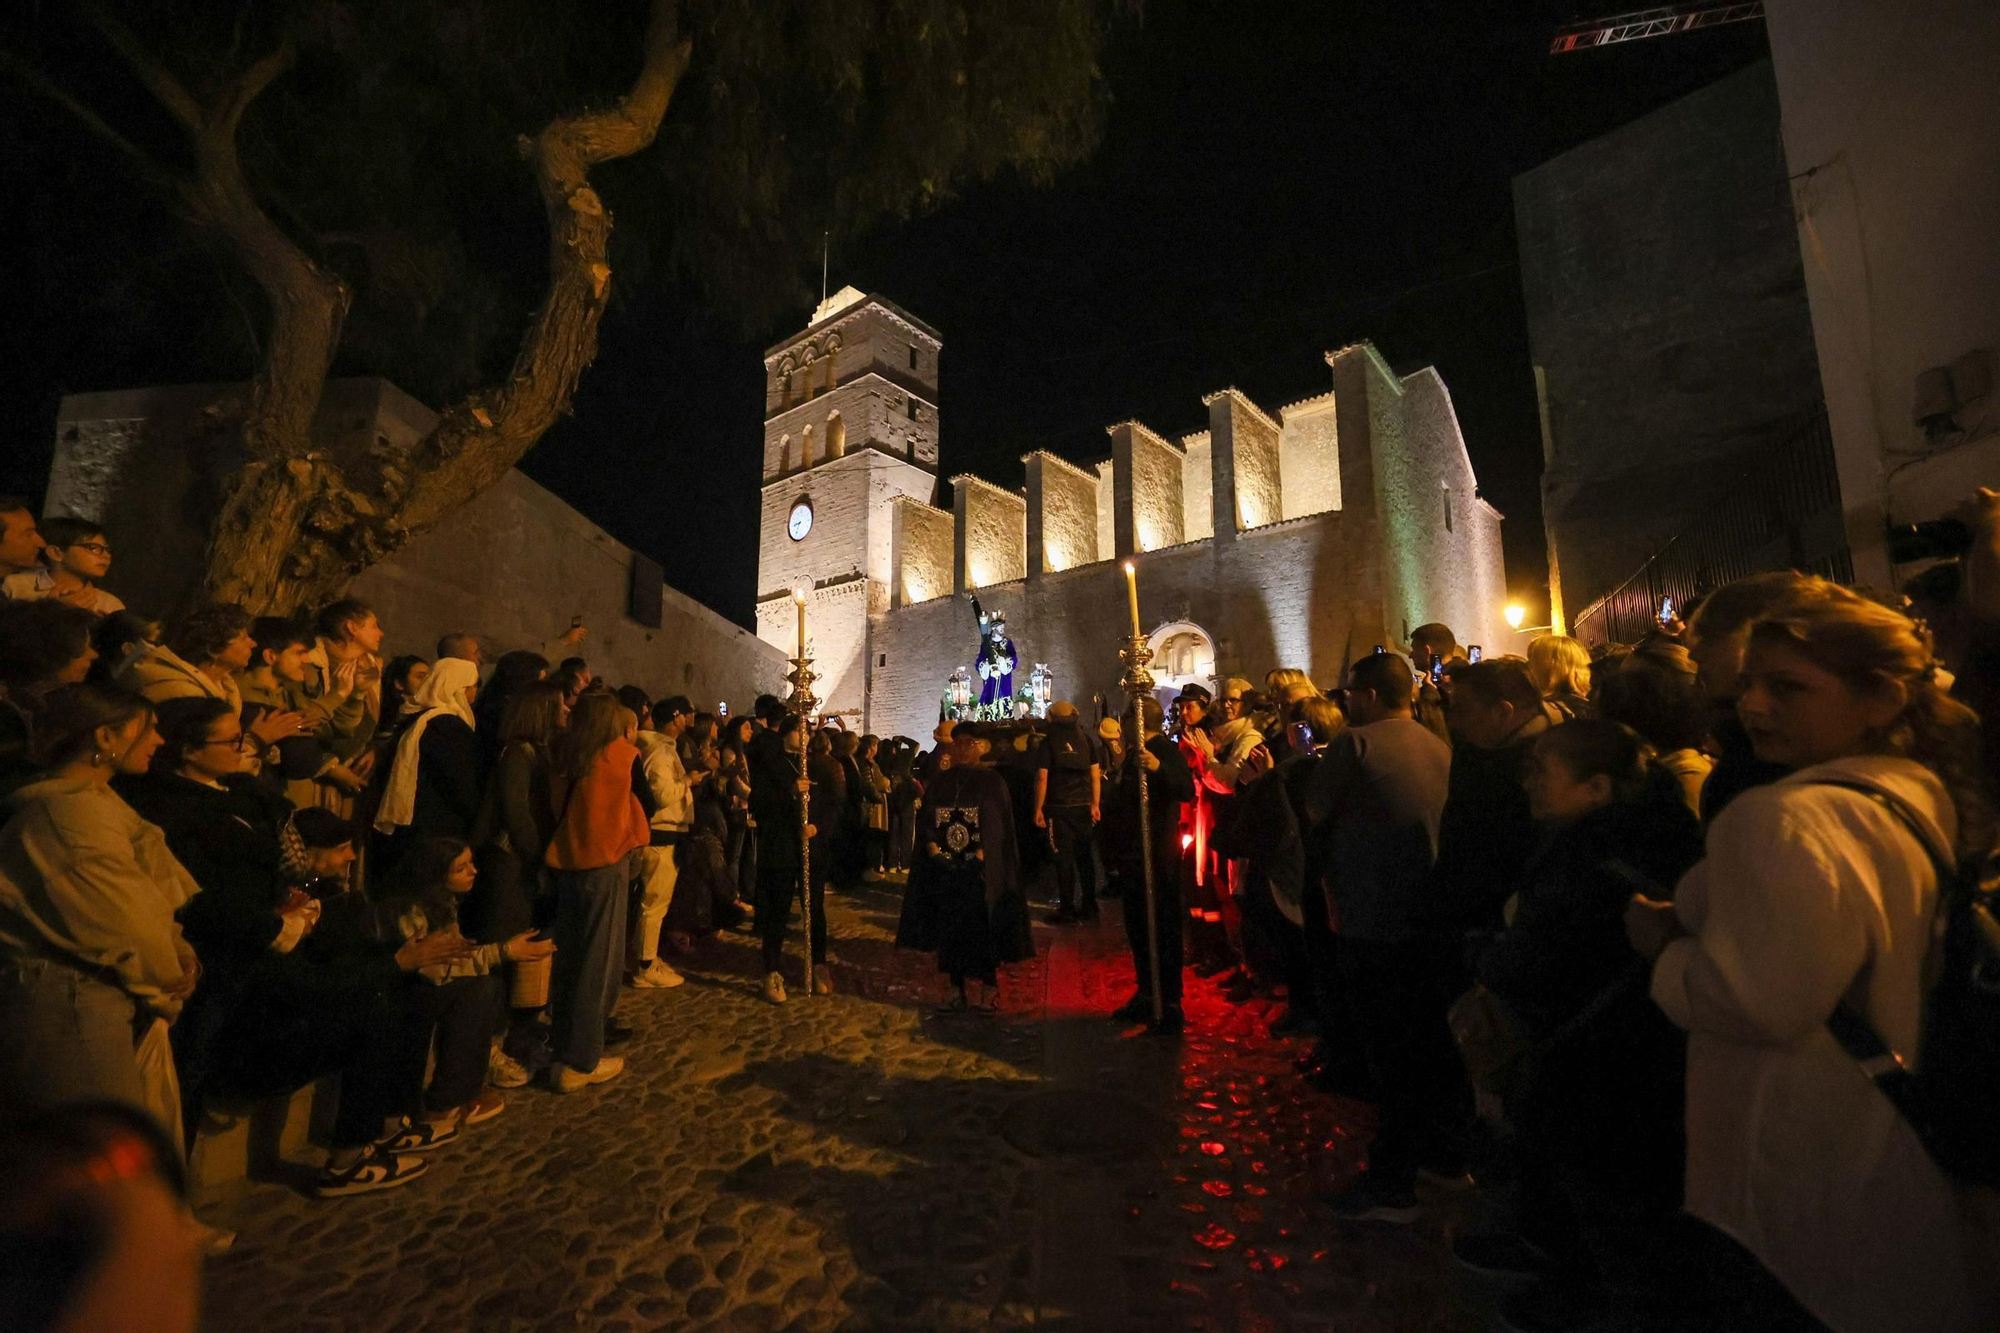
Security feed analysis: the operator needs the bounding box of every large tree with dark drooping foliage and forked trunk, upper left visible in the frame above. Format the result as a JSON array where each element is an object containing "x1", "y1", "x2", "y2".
[{"x1": 0, "y1": 0, "x2": 1112, "y2": 608}]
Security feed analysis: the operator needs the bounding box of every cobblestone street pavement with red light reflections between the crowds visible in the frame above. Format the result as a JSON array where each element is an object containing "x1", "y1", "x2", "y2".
[{"x1": 208, "y1": 876, "x2": 1486, "y2": 1333}]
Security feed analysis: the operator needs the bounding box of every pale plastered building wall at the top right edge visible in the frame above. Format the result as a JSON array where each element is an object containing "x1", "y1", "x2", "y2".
[{"x1": 1768, "y1": 0, "x2": 2000, "y2": 584}]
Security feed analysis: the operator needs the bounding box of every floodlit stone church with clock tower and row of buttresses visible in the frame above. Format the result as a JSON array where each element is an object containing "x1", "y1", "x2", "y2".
[{"x1": 758, "y1": 288, "x2": 1514, "y2": 737}]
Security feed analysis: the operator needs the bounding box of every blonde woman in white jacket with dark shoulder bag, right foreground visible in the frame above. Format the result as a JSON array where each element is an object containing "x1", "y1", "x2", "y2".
[{"x1": 1626, "y1": 578, "x2": 1992, "y2": 1331}]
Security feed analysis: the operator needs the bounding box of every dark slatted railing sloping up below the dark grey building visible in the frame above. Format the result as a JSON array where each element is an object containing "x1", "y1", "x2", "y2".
[{"x1": 1570, "y1": 406, "x2": 1854, "y2": 644}]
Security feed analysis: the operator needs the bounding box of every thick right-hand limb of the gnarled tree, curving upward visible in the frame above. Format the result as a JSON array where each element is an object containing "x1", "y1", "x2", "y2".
[{"x1": 398, "y1": 0, "x2": 692, "y2": 532}]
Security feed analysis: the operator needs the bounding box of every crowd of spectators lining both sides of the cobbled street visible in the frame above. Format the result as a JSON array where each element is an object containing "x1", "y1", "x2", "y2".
[{"x1": 0, "y1": 492, "x2": 2000, "y2": 1329}]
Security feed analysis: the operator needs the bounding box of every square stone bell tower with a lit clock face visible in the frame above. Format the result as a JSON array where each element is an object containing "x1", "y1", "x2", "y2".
[{"x1": 756, "y1": 286, "x2": 942, "y2": 729}]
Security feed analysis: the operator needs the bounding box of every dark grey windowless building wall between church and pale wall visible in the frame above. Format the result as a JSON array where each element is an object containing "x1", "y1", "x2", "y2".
[{"x1": 1514, "y1": 65, "x2": 1832, "y2": 612}]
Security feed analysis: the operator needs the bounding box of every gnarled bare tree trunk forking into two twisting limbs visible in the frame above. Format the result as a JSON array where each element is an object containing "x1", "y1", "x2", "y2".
[{"x1": 86, "y1": 0, "x2": 690, "y2": 612}]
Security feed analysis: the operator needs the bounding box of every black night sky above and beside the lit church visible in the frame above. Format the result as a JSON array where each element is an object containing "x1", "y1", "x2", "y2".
[{"x1": 11, "y1": 0, "x2": 1766, "y2": 624}]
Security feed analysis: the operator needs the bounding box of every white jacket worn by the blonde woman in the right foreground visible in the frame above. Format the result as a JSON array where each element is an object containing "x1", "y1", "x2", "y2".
[{"x1": 1652, "y1": 755, "x2": 1974, "y2": 1333}]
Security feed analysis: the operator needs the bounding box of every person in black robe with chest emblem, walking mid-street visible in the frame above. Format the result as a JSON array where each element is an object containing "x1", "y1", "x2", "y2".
[{"x1": 896, "y1": 723, "x2": 1034, "y2": 1009}]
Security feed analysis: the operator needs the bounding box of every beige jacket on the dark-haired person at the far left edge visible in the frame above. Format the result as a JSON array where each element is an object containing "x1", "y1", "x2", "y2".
[{"x1": 0, "y1": 779, "x2": 200, "y2": 1017}]
